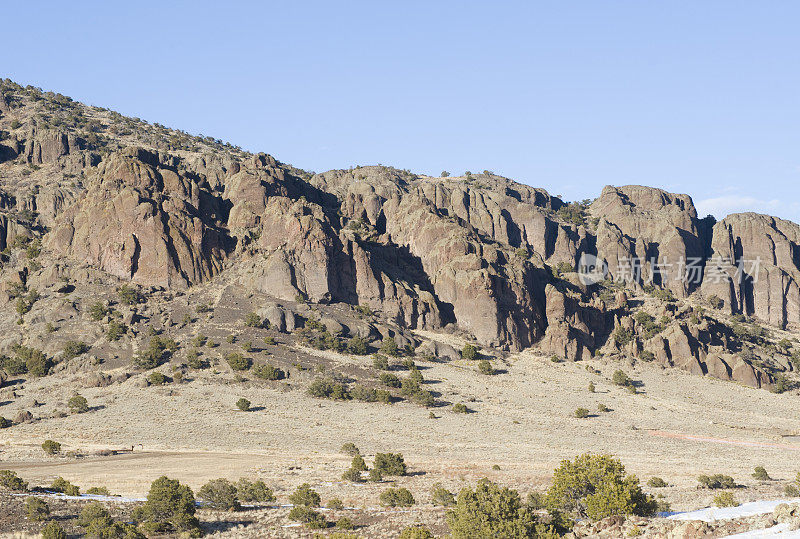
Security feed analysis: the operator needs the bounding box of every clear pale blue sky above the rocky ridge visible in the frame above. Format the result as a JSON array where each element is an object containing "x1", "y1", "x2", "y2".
[{"x1": 6, "y1": 0, "x2": 800, "y2": 222}]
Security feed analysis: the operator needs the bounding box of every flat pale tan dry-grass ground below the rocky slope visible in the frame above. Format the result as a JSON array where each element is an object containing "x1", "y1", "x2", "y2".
[{"x1": 0, "y1": 338, "x2": 800, "y2": 536}]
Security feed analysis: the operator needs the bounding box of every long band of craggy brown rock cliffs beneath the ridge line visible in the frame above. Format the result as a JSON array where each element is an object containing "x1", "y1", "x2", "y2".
[{"x1": 0, "y1": 81, "x2": 800, "y2": 385}]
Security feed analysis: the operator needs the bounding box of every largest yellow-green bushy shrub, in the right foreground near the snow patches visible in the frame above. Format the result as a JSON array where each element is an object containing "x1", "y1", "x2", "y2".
[{"x1": 546, "y1": 453, "x2": 656, "y2": 520}]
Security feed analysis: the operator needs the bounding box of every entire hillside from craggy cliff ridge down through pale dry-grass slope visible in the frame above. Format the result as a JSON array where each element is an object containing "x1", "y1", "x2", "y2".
[{"x1": 0, "y1": 80, "x2": 800, "y2": 536}]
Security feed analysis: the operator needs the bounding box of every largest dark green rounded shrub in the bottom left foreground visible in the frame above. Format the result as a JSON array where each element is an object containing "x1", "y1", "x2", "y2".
[{"x1": 133, "y1": 476, "x2": 200, "y2": 534}]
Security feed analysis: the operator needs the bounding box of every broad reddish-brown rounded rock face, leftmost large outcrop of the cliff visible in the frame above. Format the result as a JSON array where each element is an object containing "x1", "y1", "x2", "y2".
[{"x1": 47, "y1": 148, "x2": 233, "y2": 287}]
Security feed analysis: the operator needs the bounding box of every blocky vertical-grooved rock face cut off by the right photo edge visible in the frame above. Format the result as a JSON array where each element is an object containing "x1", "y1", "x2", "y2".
[{"x1": 702, "y1": 213, "x2": 800, "y2": 327}]
